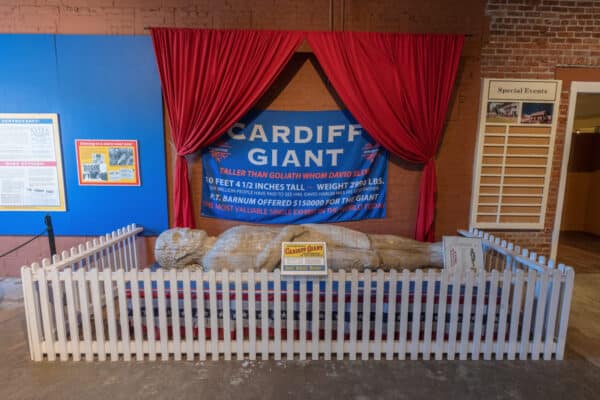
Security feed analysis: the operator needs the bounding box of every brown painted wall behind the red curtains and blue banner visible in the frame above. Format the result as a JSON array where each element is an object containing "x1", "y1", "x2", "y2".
[{"x1": 0, "y1": 0, "x2": 487, "y2": 276}]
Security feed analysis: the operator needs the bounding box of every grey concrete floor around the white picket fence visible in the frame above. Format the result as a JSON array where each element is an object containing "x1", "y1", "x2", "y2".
[{"x1": 0, "y1": 238, "x2": 600, "y2": 400}]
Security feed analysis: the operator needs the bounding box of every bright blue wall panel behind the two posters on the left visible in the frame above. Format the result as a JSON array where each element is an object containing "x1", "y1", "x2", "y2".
[{"x1": 0, "y1": 35, "x2": 168, "y2": 235}]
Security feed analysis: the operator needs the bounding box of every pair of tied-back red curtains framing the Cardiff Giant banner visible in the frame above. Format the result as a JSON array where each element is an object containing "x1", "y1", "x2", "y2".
[{"x1": 152, "y1": 28, "x2": 464, "y2": 240}]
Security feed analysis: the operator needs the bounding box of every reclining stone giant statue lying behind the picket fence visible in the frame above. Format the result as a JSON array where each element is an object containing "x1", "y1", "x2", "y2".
[{"x1": 154, "y1": 224, "x2": 442, "y2": 271}]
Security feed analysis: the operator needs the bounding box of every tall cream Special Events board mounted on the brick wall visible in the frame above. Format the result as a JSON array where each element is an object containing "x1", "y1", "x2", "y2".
[{"x1": 470, "y1": 79, "x2": 561, "y2": 229}]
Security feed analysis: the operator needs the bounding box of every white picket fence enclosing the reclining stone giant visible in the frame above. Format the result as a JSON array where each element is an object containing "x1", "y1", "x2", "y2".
[{"x1": 21, "y1": 225, "x2": 574, "y2": 361}]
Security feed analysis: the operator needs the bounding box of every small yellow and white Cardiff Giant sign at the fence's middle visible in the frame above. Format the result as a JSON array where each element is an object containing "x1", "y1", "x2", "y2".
[{"x1": 281, "y1": 242, "x2": 327, "y2": 276}]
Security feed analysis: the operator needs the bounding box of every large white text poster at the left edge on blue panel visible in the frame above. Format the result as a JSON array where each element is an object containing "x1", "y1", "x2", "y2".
[{"x1": 0, "y1": 114, "x2": 66, "y2": 211}]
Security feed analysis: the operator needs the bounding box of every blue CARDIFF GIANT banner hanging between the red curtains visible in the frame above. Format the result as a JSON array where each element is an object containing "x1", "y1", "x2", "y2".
[{"x1": 202, "y1": 111, "x2": 387, "y2": 224}]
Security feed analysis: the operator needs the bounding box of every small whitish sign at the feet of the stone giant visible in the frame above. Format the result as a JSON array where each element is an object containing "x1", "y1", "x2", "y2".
[{"x1": 443, "y1": 236, "x2": 484, "y2": 272}]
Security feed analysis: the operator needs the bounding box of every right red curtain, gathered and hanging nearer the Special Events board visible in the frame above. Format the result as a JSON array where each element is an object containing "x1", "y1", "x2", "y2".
[{"x1": 308, "y1": 32, "x2": 464, "y2": 241}]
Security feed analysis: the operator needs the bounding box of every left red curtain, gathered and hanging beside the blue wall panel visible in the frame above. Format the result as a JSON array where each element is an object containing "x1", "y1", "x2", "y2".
[{"x1": 151, "y1": 28, "x2": 303, "y2": 228}]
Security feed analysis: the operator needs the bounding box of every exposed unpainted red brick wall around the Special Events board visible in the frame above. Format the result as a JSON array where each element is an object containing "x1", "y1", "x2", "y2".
[{"x1": 481, "y1": 0, "x2": 600, "y2": 255}]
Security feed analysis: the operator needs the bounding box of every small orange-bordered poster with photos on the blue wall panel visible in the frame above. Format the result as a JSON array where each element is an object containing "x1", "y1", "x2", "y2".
[{"x1": 75, "y1": 139, "x2": 140, "y2": 186}]
